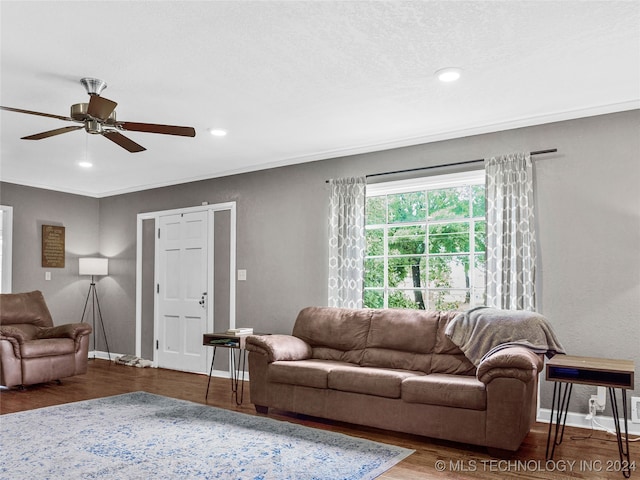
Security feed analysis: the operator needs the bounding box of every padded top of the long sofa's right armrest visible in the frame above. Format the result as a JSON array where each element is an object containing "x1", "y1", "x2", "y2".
[{"x1": 476, "y1": 347, "x2": 543, "y2": 385}]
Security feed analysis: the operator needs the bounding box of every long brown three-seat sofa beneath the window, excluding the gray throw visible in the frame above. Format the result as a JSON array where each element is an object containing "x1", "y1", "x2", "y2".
[{"x1": 246, "y1": 307, "x2": 543, "y2": 451}]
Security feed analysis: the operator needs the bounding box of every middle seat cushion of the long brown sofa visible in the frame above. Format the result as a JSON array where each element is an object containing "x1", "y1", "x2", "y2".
[{"x1": 329, "y1": 367, "x2": 425, "y2": 398}]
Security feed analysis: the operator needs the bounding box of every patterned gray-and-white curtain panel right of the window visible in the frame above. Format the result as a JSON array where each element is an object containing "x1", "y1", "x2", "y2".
[{"x1": 485, "y1": 153, "x2": 536, "y2": 311}]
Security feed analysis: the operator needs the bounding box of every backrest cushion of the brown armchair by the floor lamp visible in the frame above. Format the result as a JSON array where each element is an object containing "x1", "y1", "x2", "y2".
[{"x1": 0, "y1": 290, "x2": 53, "y2": 327}]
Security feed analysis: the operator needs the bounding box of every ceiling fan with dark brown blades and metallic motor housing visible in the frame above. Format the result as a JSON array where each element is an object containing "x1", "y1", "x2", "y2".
[{"x1": 0, "y1": 78, "x2": 196, "y2": 153}]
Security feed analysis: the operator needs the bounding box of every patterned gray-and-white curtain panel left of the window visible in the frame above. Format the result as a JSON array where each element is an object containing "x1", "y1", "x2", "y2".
[{"x1": 329, "y1": 177, "x2": 366, "y2": 308}]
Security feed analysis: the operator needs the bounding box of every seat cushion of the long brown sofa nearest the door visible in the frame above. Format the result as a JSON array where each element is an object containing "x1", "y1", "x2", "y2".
[{"x1": 267, "y1": 359, "x2": 356, "y2": 388}]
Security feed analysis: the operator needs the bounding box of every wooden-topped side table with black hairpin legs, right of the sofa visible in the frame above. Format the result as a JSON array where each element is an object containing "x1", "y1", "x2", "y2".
[{"x1": 546, "y1": 355, "x2": 635, "y2": 478}]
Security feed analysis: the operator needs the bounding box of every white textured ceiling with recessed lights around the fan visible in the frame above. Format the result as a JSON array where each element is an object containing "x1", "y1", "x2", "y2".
[{"x1": 0, "y1": 0, "x2": 640, "y2": 197}]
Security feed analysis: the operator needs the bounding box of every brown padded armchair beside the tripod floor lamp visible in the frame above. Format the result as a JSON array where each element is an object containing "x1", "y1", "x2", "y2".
[{"x1": 0, "y1": 290, "x2": 91, "y2": 387}]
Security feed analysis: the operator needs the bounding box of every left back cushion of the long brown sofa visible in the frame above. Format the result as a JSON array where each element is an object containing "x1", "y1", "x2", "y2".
[{"x1": 293, "y1": 307, "x2": 372, "y2": 363}]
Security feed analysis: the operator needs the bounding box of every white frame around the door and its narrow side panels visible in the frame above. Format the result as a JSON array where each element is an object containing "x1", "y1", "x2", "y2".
[{"x1": 135, "y1": 202, "x2": 236, "y2": 367}]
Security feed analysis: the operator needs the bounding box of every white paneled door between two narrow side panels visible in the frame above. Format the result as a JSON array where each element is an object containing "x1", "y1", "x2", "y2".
[{"x1": 155, "y1": 210, "x2": 213, "y2": 373}]
